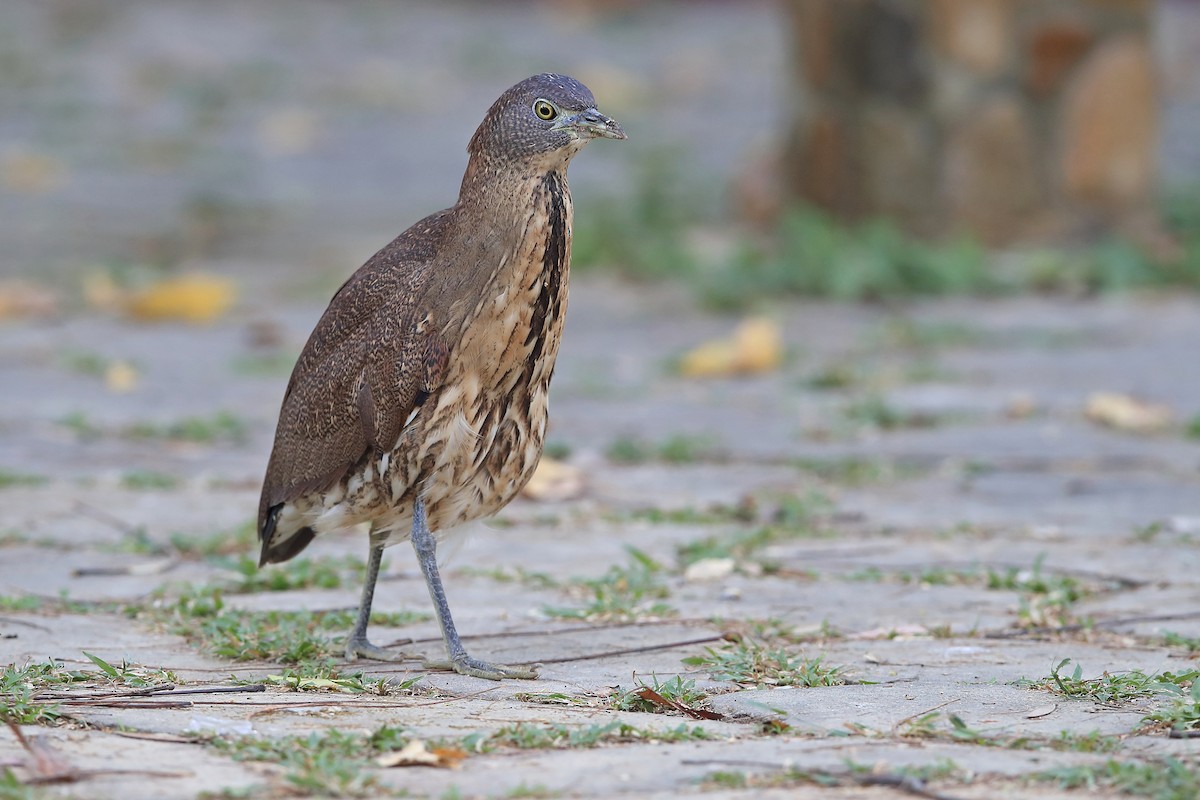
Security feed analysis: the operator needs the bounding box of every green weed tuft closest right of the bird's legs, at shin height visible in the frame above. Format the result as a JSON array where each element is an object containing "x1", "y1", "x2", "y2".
[{"x1": 542, "y1": 547, "x2": 676, "y2": 620}]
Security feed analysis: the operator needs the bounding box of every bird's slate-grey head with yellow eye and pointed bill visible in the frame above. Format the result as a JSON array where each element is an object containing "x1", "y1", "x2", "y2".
[{"x1": 467, "y1": 73, "x2": 625, "y2": 161}]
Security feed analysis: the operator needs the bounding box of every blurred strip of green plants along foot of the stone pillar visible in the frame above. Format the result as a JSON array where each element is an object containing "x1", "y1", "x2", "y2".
[{"x1": 574, "y1": 154, "x2": 1200, "y2": 309}]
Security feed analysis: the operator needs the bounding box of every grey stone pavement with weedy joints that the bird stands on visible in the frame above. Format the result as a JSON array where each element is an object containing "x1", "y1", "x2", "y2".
[{"x1": 0, "y1": 279, "x2": 1200, "y2": 798}]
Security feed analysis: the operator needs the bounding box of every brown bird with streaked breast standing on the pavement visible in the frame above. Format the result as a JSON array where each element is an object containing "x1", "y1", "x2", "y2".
[{"x1": 258, "y1": 73, "x2": 626, "y2": 680}]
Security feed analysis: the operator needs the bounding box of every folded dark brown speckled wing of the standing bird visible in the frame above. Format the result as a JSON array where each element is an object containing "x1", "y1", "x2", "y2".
[{"x1": 258, "y1": 212, "x2": 446, "y2": 537}]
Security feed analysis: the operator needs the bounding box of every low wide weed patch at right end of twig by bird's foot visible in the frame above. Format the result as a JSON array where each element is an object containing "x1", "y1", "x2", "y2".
[{"x1": 683, "y1": 640, "x2": 846, "y2": 687}]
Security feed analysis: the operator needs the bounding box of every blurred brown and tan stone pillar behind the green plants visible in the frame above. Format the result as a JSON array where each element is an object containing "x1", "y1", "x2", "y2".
[{"x1": 784, "y1": 0, "x2": 1158, "y2": 243}]
